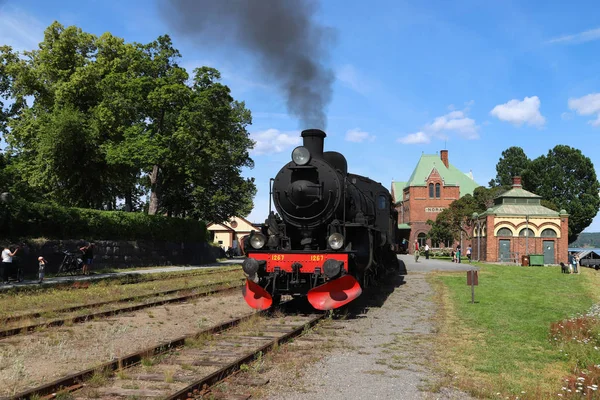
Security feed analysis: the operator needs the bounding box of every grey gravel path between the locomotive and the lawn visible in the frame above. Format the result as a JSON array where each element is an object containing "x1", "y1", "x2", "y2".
[{"x1": 267, "y1": 256, "x2": 472, "y2": 400}]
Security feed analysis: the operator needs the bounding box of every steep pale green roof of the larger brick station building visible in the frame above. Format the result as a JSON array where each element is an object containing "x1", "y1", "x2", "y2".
[{"x1": 405, "y1": 154, "x2": 481, "y2": 197}]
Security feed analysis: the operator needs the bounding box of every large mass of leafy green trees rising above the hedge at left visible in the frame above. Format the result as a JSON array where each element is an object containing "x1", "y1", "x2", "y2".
[{"x1": 0, "y1": 22, "x2": 256, "y2": 220}]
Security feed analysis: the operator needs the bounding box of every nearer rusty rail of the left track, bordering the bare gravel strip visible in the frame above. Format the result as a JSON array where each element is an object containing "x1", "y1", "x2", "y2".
[{"x1": 0, "y1": 285, "x2": 243, "y2": 338}]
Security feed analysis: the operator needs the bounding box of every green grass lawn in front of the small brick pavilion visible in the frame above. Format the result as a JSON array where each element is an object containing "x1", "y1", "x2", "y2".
[{"x1": 433, "y1": 264, "x2": 598, "y2": 399}]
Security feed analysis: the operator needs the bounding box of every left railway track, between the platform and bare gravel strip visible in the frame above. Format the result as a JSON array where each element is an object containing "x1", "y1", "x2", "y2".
[{"x1": 0, "y1": 279, "x2": 244, "y2": 338}]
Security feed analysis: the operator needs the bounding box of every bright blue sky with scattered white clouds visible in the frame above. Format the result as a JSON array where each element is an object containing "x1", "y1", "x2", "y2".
[{"x1": 0, "y1": 0, "x2": 600, "y2": 232}]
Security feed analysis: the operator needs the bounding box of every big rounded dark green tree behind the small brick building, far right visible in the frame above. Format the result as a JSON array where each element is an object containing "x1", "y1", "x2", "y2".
[{"x1": 523, "y1": 145, "x2": 600, "y2": 242}]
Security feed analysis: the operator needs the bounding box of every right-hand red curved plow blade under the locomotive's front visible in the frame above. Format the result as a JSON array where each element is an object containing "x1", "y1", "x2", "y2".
[{"x1": 307, "y1": 275, "x2": 362, "y2": 310}]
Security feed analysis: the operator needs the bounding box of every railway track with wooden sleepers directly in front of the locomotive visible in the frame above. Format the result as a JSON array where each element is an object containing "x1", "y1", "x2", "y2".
[{"x1": 11, "y1": 304, "x2": 325, "y2": 399}]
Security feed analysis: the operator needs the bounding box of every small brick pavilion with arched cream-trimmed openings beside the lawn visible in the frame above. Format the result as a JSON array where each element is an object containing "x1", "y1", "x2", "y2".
[{"x1": 472, "y1": 176, "x2": 569, "y2": 264}]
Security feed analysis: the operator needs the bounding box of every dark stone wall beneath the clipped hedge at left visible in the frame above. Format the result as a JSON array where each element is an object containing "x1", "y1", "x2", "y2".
[{"x1": 15, "y1": 240, "x2": 220, "y2": 275}]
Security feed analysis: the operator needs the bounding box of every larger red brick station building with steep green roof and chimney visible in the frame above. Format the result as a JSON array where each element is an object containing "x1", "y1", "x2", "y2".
[{"x1": 392, "y1": 150, "x2": 480, "y2": 251}]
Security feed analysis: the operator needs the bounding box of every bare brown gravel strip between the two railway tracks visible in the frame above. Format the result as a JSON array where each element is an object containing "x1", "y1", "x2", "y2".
[{"x1": 0, "y1": 293, "x2": 253, "y2": 397}]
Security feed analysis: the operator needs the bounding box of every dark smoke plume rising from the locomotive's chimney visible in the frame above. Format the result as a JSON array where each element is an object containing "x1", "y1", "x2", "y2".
[{"x1": 161, "y1": 0, "x2": 334, "y2": 128}]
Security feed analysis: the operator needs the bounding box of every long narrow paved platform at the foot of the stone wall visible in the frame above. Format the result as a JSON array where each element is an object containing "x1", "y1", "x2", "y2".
[{"x1": 0, "y1": 258, "x2": 243, "y2": 292}]
